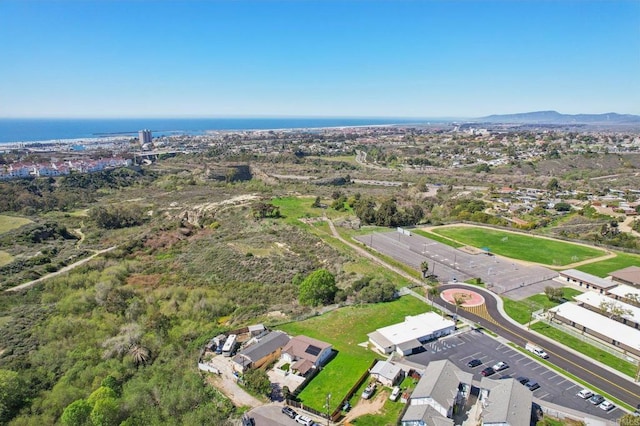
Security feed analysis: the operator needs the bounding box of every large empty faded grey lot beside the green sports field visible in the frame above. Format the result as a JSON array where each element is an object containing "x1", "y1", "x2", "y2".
[{"x1": 356, "y1": 231, "x2": 561, "y2": 300}]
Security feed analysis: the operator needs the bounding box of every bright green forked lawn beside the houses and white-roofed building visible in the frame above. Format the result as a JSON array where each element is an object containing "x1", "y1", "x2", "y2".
[{"x1": 277, "y1": 296, "x2": 430, "y2": 412}]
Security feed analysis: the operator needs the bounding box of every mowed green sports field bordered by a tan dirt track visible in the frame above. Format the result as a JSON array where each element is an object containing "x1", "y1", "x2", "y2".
[{"x1": 432, "y1": 226, "x2": 606, "y2": 266}]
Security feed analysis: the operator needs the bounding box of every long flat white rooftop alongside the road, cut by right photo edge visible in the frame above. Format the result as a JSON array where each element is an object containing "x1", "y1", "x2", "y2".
[{"x1": 549, "y1": 302, "x2": 640, "y2": 348}]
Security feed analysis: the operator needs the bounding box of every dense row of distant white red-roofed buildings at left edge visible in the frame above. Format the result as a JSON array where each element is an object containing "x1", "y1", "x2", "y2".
[{"x1": 0, "y1": 157, "x2": 132, "y2": 180}]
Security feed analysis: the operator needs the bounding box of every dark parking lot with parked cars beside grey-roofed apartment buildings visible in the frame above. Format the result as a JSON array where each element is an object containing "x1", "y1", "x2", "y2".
[{"x1": 407, "y1": 330, "x2": 625, "y2": 420}]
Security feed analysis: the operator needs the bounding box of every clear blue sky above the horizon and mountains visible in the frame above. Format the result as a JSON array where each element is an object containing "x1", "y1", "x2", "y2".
[{"x1": 0, "y1": 0, "x2": 640, "y2": 117}]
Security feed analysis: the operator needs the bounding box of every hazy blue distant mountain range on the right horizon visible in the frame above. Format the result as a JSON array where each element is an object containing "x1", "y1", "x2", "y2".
[{"x1": 478, "y1": 111, "x2": 640, "y2": 125}]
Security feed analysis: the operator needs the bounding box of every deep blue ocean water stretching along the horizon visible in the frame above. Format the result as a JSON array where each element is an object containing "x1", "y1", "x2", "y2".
[{"x1": 0, "y1": 118, "x2": 426, "y2": 143}]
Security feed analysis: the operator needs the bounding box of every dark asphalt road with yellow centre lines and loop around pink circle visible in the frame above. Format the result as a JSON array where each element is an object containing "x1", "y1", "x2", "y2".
[{"x1": 435, "y1": 284, "x2": 640, "y2": 407}]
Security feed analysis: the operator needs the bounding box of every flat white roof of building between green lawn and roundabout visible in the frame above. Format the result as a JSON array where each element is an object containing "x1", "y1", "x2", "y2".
[{"x1": 376, "y1": 312, "x2": 455, "y2": 345}]
